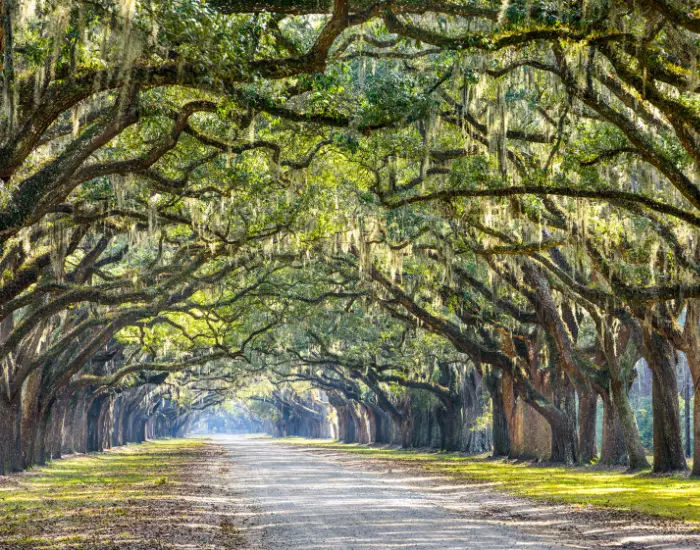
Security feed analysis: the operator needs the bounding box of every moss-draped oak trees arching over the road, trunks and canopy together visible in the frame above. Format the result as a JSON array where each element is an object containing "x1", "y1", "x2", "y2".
[{"x1": 0, "y1": 0, "x2": 700, "y2": 473}]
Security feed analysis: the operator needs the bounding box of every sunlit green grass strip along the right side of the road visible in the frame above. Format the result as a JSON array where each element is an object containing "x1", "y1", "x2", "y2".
[{"x1": 281, "y1": 438, "x2": 700, "y2": 527}]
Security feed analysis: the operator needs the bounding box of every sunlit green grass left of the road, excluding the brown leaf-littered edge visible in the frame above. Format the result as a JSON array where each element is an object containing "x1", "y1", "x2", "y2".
[{"x1": 0, "y1": 439, "x2": 204, "y2": 549}]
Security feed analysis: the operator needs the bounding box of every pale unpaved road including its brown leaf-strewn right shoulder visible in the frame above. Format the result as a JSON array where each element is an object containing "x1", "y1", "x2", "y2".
[{"x1": 226, "y1": 438, "x2": 700, "y2": 550}]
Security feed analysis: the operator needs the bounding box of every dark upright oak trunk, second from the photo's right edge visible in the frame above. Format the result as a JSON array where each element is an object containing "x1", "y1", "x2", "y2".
[{"x1": 643, "y1": 329, "x2": 688, "y2": 472}]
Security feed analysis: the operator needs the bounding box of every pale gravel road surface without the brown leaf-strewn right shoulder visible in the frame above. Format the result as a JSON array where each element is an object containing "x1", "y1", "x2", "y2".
[{"x1": 227, "y1": 438, "x2": 582, "y2": 550}]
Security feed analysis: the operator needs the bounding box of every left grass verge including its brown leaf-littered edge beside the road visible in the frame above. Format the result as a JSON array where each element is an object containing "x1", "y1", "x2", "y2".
[{"x1": 0, "y1": 439, "x2": 249, "y2": 550}]
